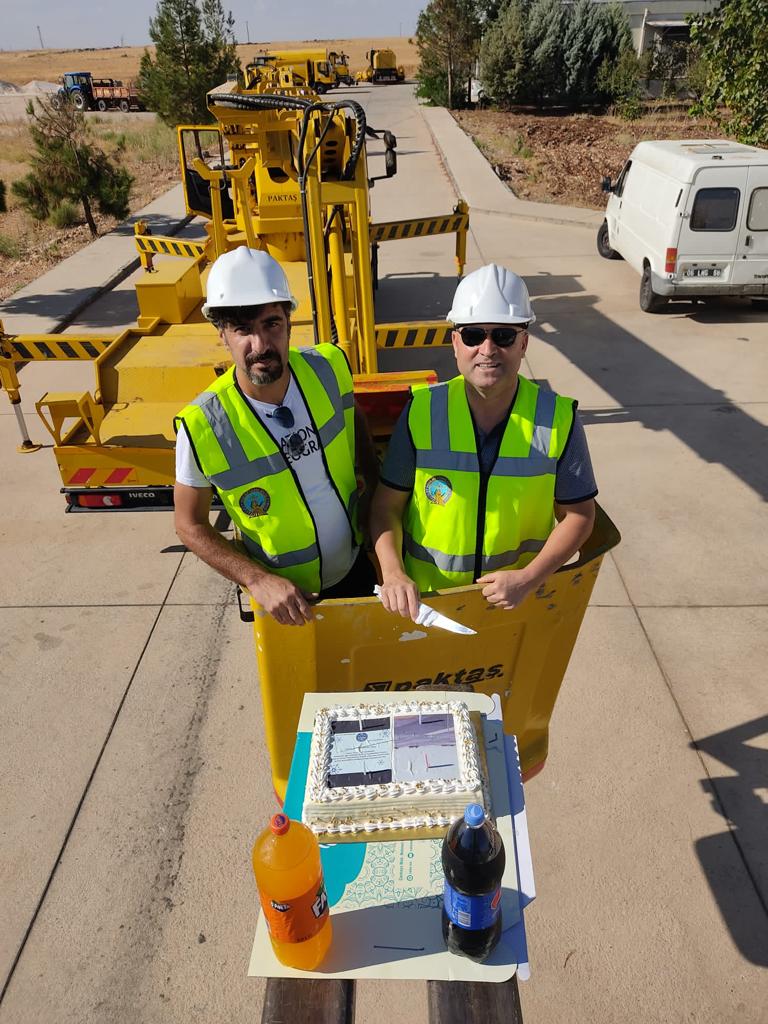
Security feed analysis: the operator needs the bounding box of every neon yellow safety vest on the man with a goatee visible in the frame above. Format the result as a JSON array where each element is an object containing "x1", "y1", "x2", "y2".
[{"x1": 175, "y1": 343, "x2": 359, "y2": 593}]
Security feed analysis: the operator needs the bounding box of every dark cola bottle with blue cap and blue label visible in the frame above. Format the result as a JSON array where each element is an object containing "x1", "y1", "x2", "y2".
[{"x1": 442, "y1": 804, "x2": 506, "y2": 963}]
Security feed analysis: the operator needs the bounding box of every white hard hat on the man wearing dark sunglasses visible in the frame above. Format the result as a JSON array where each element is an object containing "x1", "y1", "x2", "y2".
[{"x1": 445, "y1": 263, "x2": 536, "y2": 324}]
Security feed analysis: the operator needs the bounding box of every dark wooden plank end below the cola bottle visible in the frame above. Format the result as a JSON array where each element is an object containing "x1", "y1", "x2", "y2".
[{"x1": 427, "y1": 975, "x2": 522, "y2": 1024}]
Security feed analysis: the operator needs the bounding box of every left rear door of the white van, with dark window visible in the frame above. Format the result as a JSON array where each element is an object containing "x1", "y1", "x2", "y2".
[{"x1": 677, "y1": 167, "x2": 748, "y2": 285}]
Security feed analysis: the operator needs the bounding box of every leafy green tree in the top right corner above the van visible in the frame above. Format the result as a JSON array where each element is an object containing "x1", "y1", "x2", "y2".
[{"x1": 689, "y1": 0, "x2": 768, "y2": 143}]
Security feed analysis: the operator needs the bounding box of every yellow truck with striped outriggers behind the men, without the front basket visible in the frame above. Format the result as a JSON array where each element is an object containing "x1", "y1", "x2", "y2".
[{"x1": 0, "y1": 57, "x2": 468, "y2": 511}]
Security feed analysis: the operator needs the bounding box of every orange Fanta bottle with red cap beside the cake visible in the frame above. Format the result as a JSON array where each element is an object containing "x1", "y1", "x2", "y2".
[{"x1": 253, "y1": 814, "x2": 333, "y2": 971}]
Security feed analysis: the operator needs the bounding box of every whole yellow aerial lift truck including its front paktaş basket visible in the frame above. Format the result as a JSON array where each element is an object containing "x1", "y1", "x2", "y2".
[{"x1": 0, "y1": 62, "x2": 618, "y2": 797}]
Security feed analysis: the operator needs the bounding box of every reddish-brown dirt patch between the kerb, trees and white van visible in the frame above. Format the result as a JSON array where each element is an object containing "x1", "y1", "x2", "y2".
[{"x1": 454, "y1": 111, "x2": 725, "y2": 210}]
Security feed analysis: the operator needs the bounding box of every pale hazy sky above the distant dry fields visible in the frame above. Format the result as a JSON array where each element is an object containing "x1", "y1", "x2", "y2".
[{"x1": 0, "y1": 0, "x2": 427, "y2": 50}]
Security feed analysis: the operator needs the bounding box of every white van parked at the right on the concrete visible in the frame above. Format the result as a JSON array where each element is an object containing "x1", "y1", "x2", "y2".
[{"x1": 597, "y1": 139, "x2": 768, "y2": 313}]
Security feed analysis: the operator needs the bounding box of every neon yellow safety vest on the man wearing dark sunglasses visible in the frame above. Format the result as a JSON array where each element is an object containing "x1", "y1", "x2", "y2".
[{"x1": 403, "y1": 377, "x2": 575, "y2": 591}]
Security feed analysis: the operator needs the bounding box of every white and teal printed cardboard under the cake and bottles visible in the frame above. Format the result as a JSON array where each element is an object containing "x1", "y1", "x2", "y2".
[{"x1": 248, "y1": 692, "x2": 535, "y2": 982}]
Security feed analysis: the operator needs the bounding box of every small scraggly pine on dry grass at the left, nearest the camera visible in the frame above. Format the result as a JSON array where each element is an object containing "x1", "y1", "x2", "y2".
[{"x1": 11, "y1": 100, "x2": 133, "y2": 238}]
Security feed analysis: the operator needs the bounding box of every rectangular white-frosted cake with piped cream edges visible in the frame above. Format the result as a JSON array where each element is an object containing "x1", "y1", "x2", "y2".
[{"x1": 302, "y1": 698, "x2": 489, "y2": 835}]
